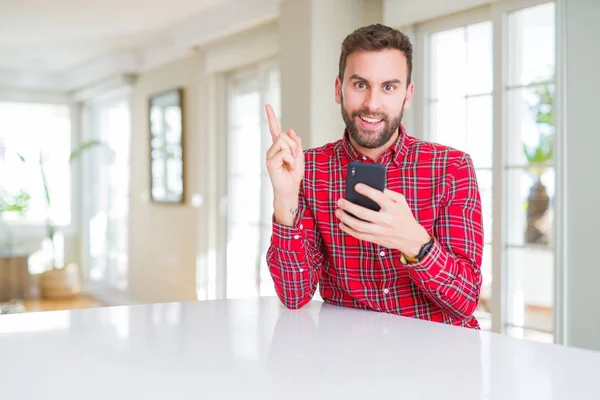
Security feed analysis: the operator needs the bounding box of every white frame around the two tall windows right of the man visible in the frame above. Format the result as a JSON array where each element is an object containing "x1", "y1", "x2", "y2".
[{"x1": 408, "y1": 0, "x2": 566, "y2": 343}]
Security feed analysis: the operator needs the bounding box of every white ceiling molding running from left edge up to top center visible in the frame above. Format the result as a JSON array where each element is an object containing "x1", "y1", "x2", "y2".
[{"x1": 0, "y1": 0, "x2": 280, "y2": 92}]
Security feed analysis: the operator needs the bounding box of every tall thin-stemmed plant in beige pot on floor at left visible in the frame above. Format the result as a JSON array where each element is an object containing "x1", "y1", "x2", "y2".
[{"x1": 19, "y1": 140, "x2": 102, "y2": 298}]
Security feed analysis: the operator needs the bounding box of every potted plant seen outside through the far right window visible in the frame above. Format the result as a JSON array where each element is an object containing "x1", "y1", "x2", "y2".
[{"x1": 523, "y1": 85, "x2": 554, "y2": 244}]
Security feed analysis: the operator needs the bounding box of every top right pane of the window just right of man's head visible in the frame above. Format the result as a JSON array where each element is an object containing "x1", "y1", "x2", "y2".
[{"x1": 466, "y1": 21, "x2": 494, "y2": 94}]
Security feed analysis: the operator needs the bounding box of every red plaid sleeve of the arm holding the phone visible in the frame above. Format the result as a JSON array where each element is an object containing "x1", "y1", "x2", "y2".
[{"x1": 409, "y1": 154, "x2": 483, "y2": 319}]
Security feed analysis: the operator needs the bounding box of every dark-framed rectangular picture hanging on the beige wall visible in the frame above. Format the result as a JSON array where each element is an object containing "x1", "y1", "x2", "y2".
[{"x1": 148, "y1": 88, "x2": 185, "y2": 204}]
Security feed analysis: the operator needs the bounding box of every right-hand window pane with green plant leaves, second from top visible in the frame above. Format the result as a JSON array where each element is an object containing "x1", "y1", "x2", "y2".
[{"x1": 507, "y1": 84, "x2": 554, "y2": 166}]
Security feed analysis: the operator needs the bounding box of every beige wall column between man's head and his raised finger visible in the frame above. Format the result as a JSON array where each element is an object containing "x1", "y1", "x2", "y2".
[{"x1": 279, "y1": 0, "x2": 383, "y2": 148}]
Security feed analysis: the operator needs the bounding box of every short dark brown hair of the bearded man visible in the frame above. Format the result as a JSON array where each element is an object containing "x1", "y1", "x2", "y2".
[{"x1": 339, "y1": 24, "x2": 412, "y2": 86}]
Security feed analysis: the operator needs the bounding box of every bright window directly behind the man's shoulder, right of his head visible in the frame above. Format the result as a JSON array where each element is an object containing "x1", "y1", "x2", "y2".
[{"x1": 427, "y1": 21, "x2": 494, "y2": 326}]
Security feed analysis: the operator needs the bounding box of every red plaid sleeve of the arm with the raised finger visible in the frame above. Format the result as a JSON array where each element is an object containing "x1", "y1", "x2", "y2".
[{"x1": 267, "y1": 188, "x2": 325, "y2": 309}]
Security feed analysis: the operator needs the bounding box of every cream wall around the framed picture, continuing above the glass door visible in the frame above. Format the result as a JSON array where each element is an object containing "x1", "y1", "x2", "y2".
[{"x1": 130, "y1": 22, "x2": 279, "y2": 302}]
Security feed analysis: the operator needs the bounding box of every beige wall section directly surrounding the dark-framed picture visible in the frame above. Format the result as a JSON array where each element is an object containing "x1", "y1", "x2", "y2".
[{"x1": 129, "y1": 55, "x2": 203, "y2": 302}]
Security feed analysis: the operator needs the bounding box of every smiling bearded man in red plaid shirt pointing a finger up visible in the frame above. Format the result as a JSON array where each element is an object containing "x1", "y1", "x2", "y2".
[{"x1": 267, "y1": 24, "x2": 483, "y2": 329}]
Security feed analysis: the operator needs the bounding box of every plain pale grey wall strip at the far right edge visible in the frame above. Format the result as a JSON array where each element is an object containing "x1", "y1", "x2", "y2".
[{"x1": 557, "y1": 0, "x2": 600, "y2": 350}]
